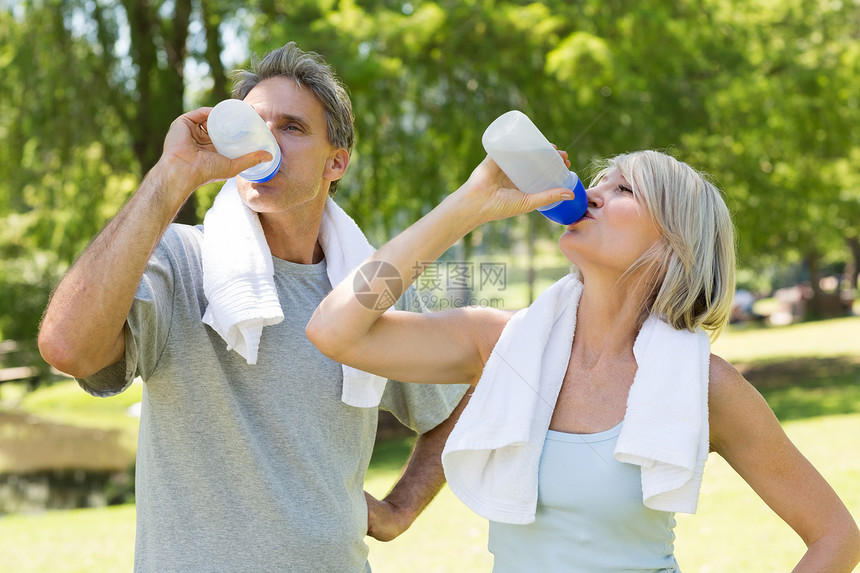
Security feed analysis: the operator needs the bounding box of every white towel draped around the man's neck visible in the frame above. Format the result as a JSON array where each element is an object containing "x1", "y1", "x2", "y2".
[{"x1": 203, "y1": 179, "x2": 386, "y2": 408}]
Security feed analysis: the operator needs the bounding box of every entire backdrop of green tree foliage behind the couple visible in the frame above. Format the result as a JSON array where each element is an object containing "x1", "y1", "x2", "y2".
[{"x1": 0, "y1": 0, "x2": 860, "y2": 346}]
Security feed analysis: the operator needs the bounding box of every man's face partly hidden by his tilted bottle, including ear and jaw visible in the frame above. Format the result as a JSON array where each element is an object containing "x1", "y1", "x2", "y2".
[{"x1": 237, "y1": 77, "x2": 349, "y2": 213}]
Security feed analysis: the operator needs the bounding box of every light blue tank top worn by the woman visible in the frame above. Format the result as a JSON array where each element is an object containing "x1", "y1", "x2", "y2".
[{"x1": 489, "y1": 424, "x2": 680, "y2": 573}]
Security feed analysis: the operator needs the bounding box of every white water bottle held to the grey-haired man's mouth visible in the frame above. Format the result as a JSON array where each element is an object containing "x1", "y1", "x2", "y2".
[{"x1": 206, "y1": 99, "x2": 281, "y2": 183}]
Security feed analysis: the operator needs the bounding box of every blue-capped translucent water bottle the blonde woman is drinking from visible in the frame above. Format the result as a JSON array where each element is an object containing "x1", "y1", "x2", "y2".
[{"x1": 481, "y1": 110, "x2": 588, "y2": 225}]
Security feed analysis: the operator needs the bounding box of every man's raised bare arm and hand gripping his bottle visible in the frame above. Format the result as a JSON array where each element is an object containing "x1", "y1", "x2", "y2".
[{"x1": 39, "y1": 108, "x2": 270, "y2": 378}]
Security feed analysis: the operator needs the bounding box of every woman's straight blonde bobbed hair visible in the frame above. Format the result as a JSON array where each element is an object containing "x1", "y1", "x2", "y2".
[{"x1": 594, "y1": 151, "x2": 735, "y2": 339}]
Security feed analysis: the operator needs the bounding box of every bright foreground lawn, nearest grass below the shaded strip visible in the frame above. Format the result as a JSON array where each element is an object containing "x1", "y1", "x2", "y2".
[{"x1": 5, "y1": 414, "x2": 860, "y2": 573}]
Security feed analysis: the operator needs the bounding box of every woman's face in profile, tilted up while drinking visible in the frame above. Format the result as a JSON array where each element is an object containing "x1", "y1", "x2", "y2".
[{"x1": 559, "y1": 169, "x2": 660, "y2": 274}]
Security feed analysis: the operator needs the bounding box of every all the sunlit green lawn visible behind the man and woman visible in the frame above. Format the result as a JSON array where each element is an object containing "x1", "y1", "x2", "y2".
[{"x1": 0, "y1": 318, "x2": 860, "y2": 573}]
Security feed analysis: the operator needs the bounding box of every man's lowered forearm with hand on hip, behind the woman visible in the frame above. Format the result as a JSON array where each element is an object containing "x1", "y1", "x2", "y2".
[{"x1": 364, "y1": 388, "x2": 472, "y2": 541}]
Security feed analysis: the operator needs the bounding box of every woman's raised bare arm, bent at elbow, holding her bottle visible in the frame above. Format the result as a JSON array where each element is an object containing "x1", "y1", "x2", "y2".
[{"x1": 306, "y1": 152, "x2": 571, "y2": 384}]
